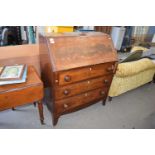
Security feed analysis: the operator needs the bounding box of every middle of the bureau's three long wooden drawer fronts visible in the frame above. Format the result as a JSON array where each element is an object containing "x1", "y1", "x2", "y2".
[{"x1": 55, "y1": 75, "x2": 112, "y2": 100}]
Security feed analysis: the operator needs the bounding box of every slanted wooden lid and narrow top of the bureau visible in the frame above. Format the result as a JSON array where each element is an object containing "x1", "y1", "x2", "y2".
[{"x1": 46, "y1": 32, "x2": 117, "y2": 71}]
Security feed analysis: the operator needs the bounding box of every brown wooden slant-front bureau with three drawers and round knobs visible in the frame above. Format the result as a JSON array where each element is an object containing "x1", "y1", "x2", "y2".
[{"x1": 39, "y1": 32, "x2": 117, "y2": 125}]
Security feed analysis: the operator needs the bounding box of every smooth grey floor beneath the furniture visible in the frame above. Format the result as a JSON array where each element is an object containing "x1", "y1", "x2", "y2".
[{"x1": 0, "y1": 83, "x2": 155, "y2": 129}]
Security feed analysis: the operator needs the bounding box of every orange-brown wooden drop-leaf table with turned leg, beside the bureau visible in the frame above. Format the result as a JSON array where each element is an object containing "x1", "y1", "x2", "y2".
[{"x1": 0, "y1": 66, "x2": 44, "y2": 124}]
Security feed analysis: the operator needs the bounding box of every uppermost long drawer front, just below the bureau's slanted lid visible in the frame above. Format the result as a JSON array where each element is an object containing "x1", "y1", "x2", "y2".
[{"x1": 57, "y1": 62, "x2": 115, "y2": 85}]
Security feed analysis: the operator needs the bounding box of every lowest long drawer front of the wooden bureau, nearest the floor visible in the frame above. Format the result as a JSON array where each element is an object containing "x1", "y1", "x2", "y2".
[{"x1": 55, "y1": 88, "x2": 107, "y2": 113}]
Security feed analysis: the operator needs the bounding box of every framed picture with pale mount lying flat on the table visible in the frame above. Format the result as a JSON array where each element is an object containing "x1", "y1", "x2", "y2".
[{"x1": 0, "y1": 65, "x2": 25, "y2": 81}]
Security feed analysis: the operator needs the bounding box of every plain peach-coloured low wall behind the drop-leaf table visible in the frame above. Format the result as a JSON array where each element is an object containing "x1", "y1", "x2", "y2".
[{"x1": 0, "y1": 44, "x2": 40, "y2": 74}]
